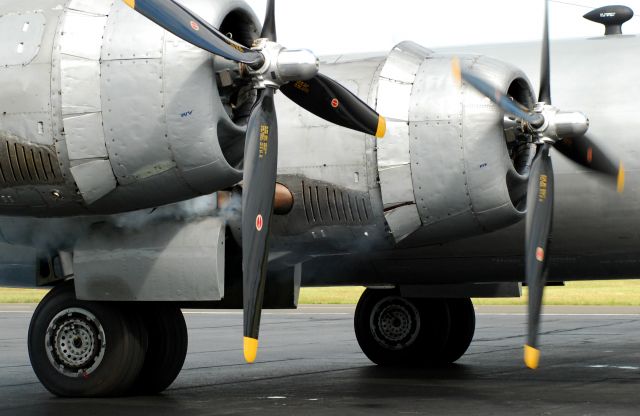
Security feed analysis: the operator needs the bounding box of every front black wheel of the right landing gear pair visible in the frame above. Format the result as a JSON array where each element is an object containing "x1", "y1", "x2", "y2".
[{"x1": 354, "y1": 289, "x2": 450, "y2": 367}]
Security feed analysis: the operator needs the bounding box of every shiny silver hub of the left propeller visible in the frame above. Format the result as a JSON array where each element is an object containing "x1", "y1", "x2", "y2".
[{"x1": 247, "y1": 39, "x2": 320, "y2": 89}]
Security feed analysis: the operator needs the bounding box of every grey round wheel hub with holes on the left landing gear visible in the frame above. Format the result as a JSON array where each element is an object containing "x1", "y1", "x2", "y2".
[{"x1": 45, "y1": 308, "x2": 106, "y2": 377}]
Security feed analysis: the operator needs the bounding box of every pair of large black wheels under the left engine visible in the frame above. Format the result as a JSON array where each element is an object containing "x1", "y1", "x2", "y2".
[{"x1": 28, "y1": 282, "x2": 187, "y2": 397}]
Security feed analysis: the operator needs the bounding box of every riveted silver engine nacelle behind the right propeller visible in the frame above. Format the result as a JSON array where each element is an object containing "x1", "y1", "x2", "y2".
[{"x1": 264, "y1": 42, "x2": 534, "y2": 255}]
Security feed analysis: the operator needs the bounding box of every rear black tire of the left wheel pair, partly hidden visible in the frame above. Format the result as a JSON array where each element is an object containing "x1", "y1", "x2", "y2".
[{"x1": 133, "y1": 305, "x2": 189, "y2": 395}]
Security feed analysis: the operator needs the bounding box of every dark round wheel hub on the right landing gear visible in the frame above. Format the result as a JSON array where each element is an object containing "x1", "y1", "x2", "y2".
[{"x1": 370, "y1": 296, "x2": 420, "y2": 350}]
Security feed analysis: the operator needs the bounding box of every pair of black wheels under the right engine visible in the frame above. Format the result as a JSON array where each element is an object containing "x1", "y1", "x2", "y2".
[{"x1": 354, "y1": 289, "x2": 476, "y2": 367}]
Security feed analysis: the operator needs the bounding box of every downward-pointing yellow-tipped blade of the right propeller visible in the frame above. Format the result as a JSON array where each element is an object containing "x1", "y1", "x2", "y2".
[{"x1": 524, "y1": 143, "x2": 553, "y2": 369}]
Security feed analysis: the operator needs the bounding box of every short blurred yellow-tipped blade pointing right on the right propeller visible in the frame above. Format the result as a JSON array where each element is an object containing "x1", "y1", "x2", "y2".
[{"x1": 555, "y1": 135, "x2": 624, "y2": 193}]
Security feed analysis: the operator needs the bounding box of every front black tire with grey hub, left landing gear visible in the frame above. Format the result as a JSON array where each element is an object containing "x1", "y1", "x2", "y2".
[{"x1": 28, "y1": 282, "x2": 146, "y2": 397}]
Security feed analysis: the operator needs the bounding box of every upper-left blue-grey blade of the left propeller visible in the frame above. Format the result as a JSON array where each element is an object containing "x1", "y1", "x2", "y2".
[{"x1": 124, "y1": 0, "x2": 264, "y2": 67}]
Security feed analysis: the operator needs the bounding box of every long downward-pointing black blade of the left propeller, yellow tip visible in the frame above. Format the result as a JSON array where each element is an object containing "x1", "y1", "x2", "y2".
[{"x1": 242, "y1": 88, "x2": 278, "y2": 363}]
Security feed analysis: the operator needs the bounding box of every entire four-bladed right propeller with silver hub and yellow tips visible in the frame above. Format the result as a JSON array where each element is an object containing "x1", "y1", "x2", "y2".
[{"x1": 452, "y1": 0, "x2": 624, "y2": 369}]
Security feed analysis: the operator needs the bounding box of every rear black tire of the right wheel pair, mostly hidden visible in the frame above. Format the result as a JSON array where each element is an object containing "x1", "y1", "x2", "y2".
[{"x1": 442, "y1": 298, "x2": 476, "y2": 364}]
